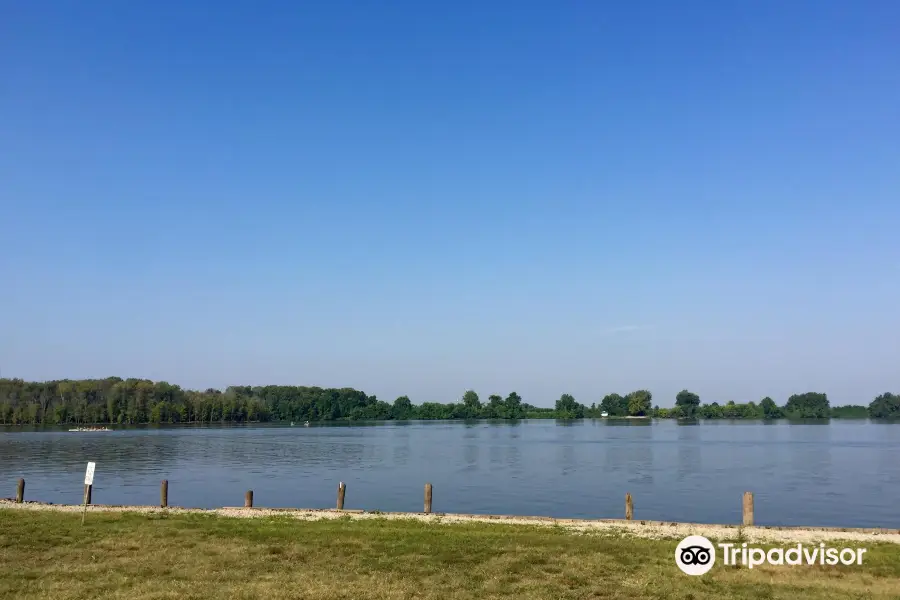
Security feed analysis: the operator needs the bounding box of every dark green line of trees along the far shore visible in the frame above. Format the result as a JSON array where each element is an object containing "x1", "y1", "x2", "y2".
[{"x1": 0, "y1": 377, "x2": 900, "y2": 425}]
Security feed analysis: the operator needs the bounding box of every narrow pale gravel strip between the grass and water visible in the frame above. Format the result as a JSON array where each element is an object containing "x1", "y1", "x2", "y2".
[{"x1": 0, "y1": 500, "x2": 900, "y2": 544}]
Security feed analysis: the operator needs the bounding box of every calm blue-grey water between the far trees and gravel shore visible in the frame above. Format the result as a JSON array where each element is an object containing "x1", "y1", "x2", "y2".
[{"x1": 0, "y1": 420, "x2": 900, "y2": 527}]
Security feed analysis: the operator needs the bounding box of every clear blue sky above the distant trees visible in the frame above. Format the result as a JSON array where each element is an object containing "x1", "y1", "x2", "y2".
[{"x1": 0, "y1": 0, "x2": 900, "y2": 406}]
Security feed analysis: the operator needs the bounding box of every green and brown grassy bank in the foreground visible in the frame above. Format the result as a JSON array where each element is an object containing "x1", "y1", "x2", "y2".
[{"x1": 0, "y1": 508, "x2": 900, "y2": 600}]
